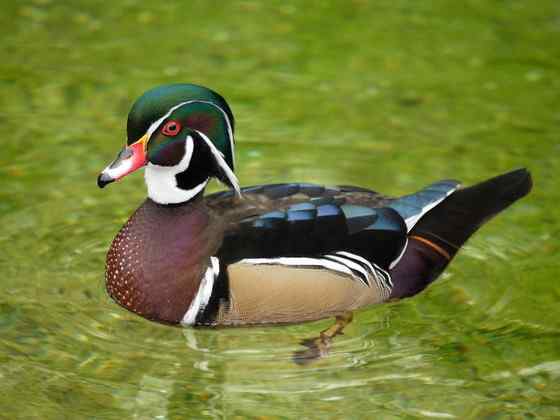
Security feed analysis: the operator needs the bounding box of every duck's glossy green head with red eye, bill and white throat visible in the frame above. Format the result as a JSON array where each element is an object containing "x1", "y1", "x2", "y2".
[{"x1": 97, "y1": 84, "x2": 239, "y2": 204}]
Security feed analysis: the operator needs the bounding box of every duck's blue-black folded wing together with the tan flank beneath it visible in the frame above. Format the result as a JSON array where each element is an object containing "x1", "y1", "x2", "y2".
[{"x1": 197, "y1": 184, "x2": 407, "y2": 325}]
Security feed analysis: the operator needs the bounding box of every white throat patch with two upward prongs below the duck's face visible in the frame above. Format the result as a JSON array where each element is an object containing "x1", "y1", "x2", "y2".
[{"x1": 144, "y1": 136, "x2": 209, "y2": 204}]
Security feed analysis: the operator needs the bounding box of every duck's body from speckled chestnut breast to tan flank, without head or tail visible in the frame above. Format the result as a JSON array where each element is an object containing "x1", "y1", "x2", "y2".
[{"x1": 107, "y1": 184, "x2": 406, "y2": 325}]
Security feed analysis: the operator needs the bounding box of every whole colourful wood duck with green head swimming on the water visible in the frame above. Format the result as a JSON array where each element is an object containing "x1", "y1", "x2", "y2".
[{"x1": 97, "y1": 83, "x2": 532, "y2": 336}]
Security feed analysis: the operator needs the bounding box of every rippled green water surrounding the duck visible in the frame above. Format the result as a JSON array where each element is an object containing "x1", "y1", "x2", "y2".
[{"x1": 0, "y1": 0, "x2": 560, "y2": 419}]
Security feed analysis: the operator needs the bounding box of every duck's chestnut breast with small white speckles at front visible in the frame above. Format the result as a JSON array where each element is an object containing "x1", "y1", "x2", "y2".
[{"x1": 105, "y1": 199, "x2": 222, "y2": 324}]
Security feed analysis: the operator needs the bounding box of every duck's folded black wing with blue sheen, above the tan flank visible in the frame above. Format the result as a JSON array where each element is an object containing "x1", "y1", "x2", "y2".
[{"x1": 214, "y1": 184, "x2": 406, "y2": 269}]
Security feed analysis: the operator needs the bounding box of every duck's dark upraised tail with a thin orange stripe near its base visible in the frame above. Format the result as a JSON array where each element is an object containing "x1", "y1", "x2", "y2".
[{"x1": 391, "y1": 169, "x2": 533, "y2": 298}]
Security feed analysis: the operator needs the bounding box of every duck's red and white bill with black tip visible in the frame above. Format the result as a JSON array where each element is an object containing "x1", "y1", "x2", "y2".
[{"x1": 97, "y1": 135, "x2": 148, "y2": 188}]
